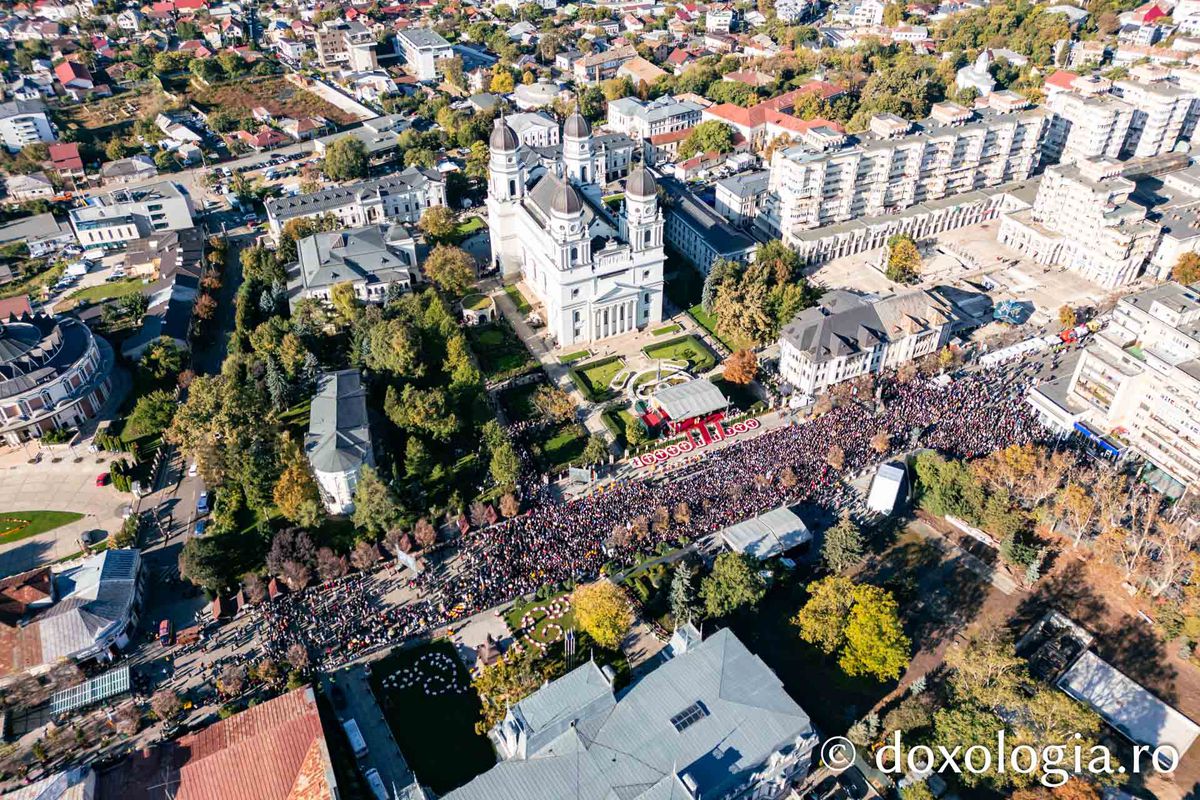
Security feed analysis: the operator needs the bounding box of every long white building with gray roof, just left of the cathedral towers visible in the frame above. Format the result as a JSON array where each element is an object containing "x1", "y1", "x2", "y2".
[{"x1": 265, "y1": 167, "x2": 446, "y2": 239}]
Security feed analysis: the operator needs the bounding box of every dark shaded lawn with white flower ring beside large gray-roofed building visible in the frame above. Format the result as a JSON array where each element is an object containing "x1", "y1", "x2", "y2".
[{"x1": 371, "y1": 639, "x2": 496, "y2": 795}]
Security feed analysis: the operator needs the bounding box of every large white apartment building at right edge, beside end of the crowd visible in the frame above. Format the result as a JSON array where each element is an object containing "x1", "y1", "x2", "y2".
[{"x1": 1027, "y1": 283, "x2": 1200, "y2": 486}]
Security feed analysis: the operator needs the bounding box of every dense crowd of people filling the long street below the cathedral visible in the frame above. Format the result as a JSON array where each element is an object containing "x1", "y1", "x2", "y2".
[{"x1": 264, "y1": 371, "x2": 1044, "y2": 668}]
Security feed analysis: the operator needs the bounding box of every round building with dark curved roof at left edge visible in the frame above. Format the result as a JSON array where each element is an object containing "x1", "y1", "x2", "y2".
[{"x1": 0, "y1": 314, "x2": 113, "y2": 445}]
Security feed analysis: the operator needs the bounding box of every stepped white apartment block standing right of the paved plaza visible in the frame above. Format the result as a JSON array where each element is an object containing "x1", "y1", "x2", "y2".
[{"x1": 997, "y1": 161, "x2": 1159, "y2": 289}]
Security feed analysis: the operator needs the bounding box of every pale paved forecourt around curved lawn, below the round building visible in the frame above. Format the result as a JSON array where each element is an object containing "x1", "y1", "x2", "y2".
[{"x1": 0, "y1": 446, "x2": 133, "y2": 576}]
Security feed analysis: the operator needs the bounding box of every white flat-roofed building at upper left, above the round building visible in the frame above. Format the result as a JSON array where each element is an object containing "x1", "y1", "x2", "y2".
[{"x1": 71, "y1": 181, "x2": 192, "y2": 249}]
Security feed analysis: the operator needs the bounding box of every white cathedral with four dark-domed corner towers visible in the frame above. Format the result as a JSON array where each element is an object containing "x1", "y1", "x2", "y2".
[{"x1": 487, "y1": 113, "x2": 665, "y2": 347}]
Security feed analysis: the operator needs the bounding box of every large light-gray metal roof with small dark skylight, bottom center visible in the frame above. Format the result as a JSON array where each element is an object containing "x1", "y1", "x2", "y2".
[{"x1": 446, "y1": 630, "x2": 817, "y2": 800}]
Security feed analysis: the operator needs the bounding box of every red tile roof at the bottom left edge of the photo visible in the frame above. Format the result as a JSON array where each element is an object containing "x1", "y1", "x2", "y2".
[{"x1": 175, "y1": 687, "x2": 334, "y2": 800}]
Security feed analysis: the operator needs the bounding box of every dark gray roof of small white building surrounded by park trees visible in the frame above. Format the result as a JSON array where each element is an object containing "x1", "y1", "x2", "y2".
[{"x1": 304, "y1": 369, "x2": 374, "y2": 473}]
